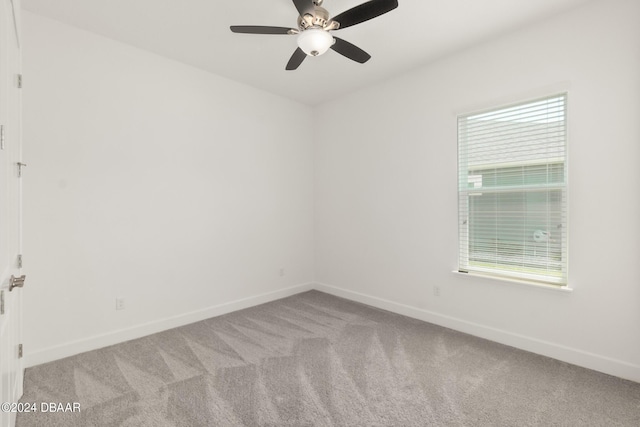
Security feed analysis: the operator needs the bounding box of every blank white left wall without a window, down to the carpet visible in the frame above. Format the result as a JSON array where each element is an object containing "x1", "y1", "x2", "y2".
[{"x1": 23, "y1": 12, "x2": 313, "y2": 365}]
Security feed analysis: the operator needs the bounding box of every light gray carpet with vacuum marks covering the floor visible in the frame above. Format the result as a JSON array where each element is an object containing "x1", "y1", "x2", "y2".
[{"x1": 17, "y1": 291, "x2": 640, "y2": 427}]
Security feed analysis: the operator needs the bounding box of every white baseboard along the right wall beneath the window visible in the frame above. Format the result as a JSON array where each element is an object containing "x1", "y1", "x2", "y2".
[{"x1": 313, "y1": 283, "x2": 640, "y2": 382}]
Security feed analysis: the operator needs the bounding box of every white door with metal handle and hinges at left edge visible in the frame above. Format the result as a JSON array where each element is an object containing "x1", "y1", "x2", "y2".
[{"x1": 0, "y1": 0, "x2": 24, "y2": 427}]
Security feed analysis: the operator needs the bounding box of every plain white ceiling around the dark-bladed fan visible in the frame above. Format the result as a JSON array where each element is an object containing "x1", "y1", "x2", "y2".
[{"x1": 22, "y1": 0, "x2": 589, "y2": 105}]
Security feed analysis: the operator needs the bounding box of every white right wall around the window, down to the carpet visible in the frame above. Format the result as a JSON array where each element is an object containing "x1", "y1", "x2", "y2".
[{"x1": 314, "y1": 0, "x2": 640, "y2": 381}]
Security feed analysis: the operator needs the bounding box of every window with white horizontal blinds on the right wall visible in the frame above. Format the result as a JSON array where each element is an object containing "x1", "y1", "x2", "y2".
[{"x1": 458, "y1": 94, "x2": 567, "y2": 286}]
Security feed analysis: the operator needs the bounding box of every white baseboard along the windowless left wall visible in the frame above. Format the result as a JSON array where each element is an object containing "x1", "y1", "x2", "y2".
[{"x1": 25, "y1": 283, "x2": 313, "y2": 368}]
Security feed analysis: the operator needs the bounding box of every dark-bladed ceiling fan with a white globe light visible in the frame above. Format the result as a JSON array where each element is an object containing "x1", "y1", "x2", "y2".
[{"x1": 231, "y1": 0, "x2": 398, "y2": 70}]
